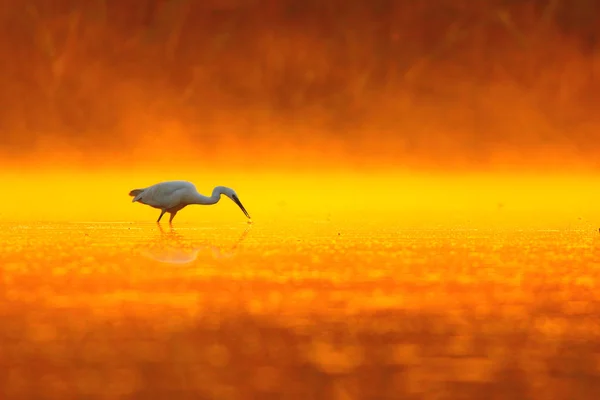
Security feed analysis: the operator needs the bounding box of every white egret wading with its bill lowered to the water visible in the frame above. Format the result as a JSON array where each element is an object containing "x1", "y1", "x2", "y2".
[{"x1": 129, "y1": 181, "x2": 250, "y2": 223}]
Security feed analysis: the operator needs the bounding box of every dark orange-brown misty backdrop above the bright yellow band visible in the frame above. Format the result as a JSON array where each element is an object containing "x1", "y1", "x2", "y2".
[{"x1": 0, "y1": 0, "x2": 600, "y2": 171}]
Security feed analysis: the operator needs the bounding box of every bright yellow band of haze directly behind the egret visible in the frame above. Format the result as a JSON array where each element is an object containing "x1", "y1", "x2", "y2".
[{"x1": 0, "y1": 168, "x2": 600, "y2": 229}]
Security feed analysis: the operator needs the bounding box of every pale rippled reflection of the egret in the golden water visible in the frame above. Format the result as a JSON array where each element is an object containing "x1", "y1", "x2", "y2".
[{"x1": 140, "y1": 224, "x2": 250, "y2": 264}]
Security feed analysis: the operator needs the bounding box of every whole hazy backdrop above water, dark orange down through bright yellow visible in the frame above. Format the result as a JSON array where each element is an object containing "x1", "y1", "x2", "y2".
[{"x1": 0, "y1": 0, "x2": 600, "y2": 225}]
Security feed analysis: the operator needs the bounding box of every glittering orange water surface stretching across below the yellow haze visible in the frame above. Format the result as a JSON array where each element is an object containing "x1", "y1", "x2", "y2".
[{"x1": 0, "y1": 221, "x2": 600, "y2": 400}]
